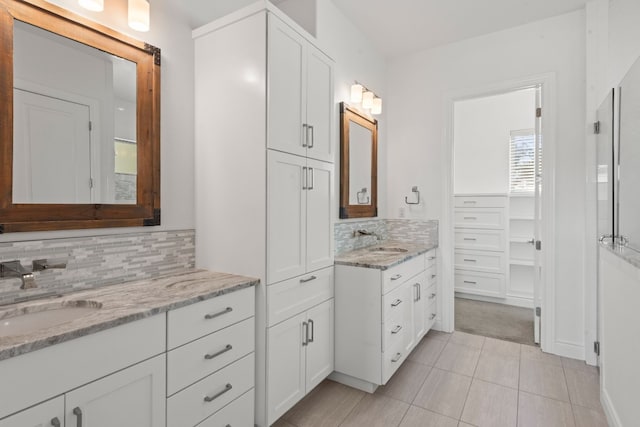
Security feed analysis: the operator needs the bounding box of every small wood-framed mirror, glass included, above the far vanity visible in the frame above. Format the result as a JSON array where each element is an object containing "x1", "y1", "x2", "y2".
[{"x1": 340, "y1": 102, "x2": 378, "y2": 219}]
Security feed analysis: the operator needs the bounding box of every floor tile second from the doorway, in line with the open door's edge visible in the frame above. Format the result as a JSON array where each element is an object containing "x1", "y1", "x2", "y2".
[{"x1": 520, "y1": 359, "x2": 569, "y2": 402}]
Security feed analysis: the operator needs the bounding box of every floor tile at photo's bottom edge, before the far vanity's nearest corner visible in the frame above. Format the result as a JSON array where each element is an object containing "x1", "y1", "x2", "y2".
[{"x1": 340, "y1": 394, "x2": 409, "y2": 427}]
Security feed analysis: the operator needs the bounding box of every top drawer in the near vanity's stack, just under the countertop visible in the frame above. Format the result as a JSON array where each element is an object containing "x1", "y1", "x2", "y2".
[{"x1": 167, "y1": 287, "x2": 255, "y2": 349}]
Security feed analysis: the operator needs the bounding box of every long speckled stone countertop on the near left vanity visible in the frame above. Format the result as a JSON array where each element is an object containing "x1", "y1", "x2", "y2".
[{"x1": 0, "y1": 270, "x2": 259, "y2": 360}]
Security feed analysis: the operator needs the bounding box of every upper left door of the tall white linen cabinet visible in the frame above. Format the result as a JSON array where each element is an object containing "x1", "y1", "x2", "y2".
[{"x1": 267, "y1": 14, "x2": 307, "y2": 156}]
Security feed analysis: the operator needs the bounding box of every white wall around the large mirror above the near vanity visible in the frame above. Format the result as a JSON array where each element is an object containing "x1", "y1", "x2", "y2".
[{"x1": 0, "y1": 0, "x2": 194, "y2": 242}]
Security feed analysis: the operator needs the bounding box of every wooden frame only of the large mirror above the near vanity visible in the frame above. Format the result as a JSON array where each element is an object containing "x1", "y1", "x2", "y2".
[{"x1": 0, "y1": 0, "x2": 160, "y2": 233}]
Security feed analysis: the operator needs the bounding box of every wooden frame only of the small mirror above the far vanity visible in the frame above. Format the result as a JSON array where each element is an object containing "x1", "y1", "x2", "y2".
[{"x1": 340, "y1": 102, "x2": 378, "y2": 219}]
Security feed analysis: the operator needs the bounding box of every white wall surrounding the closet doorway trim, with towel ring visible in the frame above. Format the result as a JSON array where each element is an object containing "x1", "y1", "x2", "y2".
[{"x1": 387, "y1": 11, "x2": 585, "y2": 357}]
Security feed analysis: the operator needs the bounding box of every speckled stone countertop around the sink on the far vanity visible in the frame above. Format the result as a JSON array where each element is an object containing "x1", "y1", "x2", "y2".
[{"x1": 334, "y1": 240, "x2": 438, "y2": 270}]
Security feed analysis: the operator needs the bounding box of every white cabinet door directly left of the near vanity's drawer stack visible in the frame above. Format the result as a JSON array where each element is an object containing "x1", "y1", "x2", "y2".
[{"x1": 65, "y1": 355, "x2": 166, "y2": 427}]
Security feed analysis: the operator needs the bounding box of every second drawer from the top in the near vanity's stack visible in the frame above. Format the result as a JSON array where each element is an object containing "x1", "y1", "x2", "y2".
[{"x1": 167, "y1": 317, "x2": 255, "y2": 396}]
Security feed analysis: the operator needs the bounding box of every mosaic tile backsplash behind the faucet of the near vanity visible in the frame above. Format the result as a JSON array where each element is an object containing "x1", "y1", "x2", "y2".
[{"x1": 0, "y1": 230, "x2": 195, "y2": 304}]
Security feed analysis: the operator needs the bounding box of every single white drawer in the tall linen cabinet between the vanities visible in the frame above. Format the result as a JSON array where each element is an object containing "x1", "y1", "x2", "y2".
[{"x1": 267, "y1": 267, "x2": 333, "y2": 326}]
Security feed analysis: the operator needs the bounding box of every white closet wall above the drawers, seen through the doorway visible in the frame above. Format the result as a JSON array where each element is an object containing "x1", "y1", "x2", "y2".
[{"x1": 453, "y1": 89, "x2": 536, "y2": 194}]
